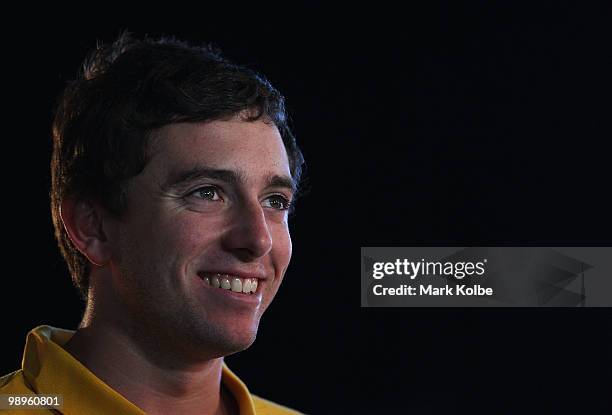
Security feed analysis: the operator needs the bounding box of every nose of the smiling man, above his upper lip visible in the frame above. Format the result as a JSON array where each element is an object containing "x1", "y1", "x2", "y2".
[{"x1": 223, "y1": 203, "x2": 272, "y2": 262}]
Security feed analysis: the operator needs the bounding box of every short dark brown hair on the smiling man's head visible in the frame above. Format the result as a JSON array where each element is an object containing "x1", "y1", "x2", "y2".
[{"x1": 50, "y1": 32, "x2": 304, "y2": 298}]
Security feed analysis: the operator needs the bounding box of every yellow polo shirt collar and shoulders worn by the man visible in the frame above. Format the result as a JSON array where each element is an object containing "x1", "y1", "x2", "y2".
[{"x1": 0, "y1": 326, "x2": 299, "y2": 415}]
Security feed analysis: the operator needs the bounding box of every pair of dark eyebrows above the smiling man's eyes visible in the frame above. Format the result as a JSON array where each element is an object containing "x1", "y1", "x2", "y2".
[{"x1": 162, "y1": 165, "x2": 297, "y2": 193}]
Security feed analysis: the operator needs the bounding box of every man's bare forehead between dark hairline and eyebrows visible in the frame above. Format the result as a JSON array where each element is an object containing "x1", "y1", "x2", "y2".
[{"x1": 147, "y1": 118, "x2": 290, "y2": 180}]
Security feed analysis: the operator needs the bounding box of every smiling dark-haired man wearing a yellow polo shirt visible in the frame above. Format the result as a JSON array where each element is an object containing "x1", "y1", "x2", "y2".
[{"x1": 0, "y1": 34, "x2": 303, "y2": 415}]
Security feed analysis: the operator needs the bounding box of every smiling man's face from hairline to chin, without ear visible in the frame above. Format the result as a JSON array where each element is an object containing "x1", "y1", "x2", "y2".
[{"x1": 105, "y1": 118, "x2": 293, "y2": 357}]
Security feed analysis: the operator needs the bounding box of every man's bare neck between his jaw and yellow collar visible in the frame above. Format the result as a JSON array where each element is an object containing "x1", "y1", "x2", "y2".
[{"x1": 64, "y1": 319, "x2": 236, "y2": 415}]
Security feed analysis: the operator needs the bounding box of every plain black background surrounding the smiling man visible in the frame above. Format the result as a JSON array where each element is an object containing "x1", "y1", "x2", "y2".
[{"x1": 0, "y1": 2, "x2": 612, "y2": 414}]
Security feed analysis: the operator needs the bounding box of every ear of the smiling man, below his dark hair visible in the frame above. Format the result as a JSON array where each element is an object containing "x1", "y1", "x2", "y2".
[{"x1": 60, "y1": 199, "x2": 111, "y2": 266}]
